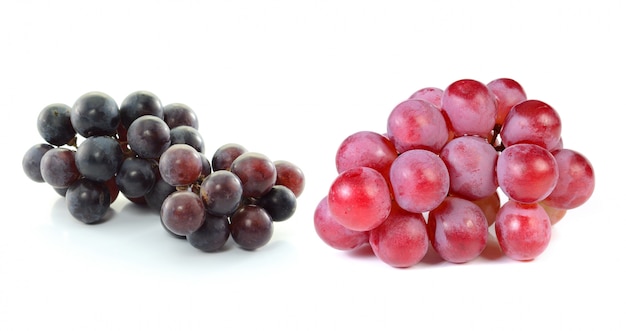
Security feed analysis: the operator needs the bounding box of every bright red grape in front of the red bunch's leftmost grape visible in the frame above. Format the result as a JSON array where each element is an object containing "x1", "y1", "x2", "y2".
[{"x1": 328, "y1": 167, "x2": 391, "y2": 231}]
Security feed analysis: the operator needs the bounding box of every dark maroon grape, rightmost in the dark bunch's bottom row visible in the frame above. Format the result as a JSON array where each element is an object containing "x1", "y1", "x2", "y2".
[{"x1": 230, "y1": 205, "x2": 274, "y2": 250}]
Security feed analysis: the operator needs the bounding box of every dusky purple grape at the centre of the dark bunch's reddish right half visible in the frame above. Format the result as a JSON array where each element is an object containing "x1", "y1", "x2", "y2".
[{"x1": 200, "y1": 170, "x2": 243, "y2": 216}]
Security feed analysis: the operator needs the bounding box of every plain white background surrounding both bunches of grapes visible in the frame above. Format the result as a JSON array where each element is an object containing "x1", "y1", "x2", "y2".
[{"x1": 0, "y1": 0, "x2": 626, "y2": 330}]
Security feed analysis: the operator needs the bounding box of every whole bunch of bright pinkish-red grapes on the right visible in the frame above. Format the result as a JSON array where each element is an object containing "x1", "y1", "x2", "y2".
[{"x1": 314, "y1": 78, "x2": 595, "y2": 267}]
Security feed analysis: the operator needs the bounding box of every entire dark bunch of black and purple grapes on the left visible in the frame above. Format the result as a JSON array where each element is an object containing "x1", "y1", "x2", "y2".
[{"x1": 22, "y1": 91, "x2": 304, "y2": 251}]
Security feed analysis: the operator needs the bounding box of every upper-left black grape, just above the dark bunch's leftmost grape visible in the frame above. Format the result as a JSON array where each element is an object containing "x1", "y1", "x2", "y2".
[{"x1": 37, "y1": 103, "x2": 76, "y2": 146}]
